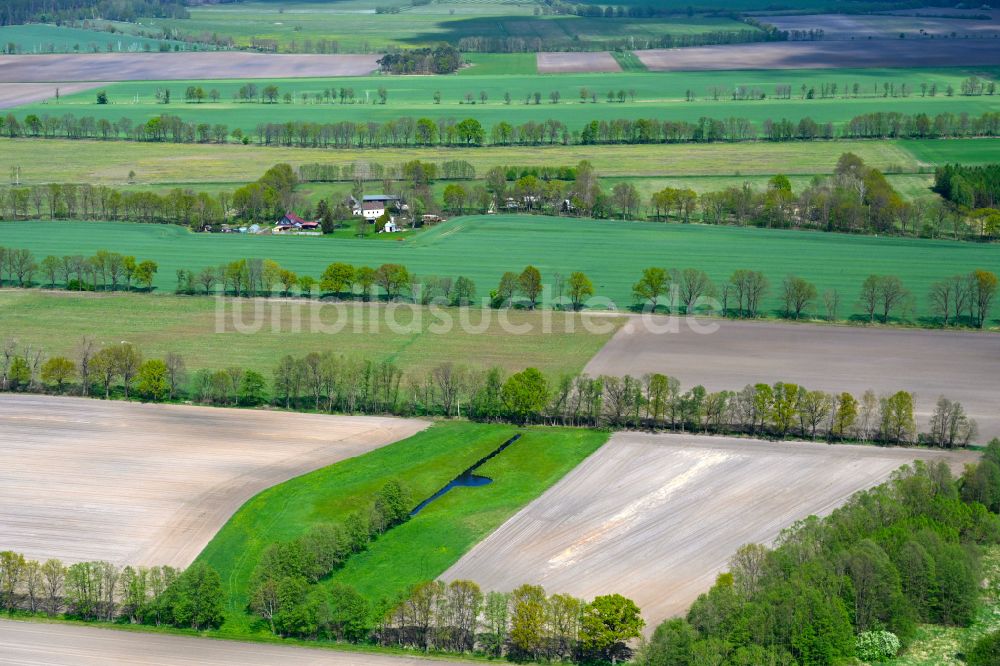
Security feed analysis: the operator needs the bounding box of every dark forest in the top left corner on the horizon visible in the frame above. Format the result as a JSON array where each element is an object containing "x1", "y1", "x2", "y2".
[{"x1": 0, "y1": 0, "x2": 188, "y2": 25}]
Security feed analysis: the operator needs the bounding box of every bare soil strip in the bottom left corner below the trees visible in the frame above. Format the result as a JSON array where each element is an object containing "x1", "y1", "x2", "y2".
[{"x1": 0, "y1": 620, "x2": 455, "y2": 666}]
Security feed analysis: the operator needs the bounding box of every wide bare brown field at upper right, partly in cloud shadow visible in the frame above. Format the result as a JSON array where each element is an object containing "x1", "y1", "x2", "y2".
[{"x1": 635, "y1": 39, "x2": 1000, "y2": 72}]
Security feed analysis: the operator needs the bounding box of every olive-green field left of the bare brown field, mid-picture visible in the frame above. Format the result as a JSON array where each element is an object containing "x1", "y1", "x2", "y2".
[{"x1": 0, "y1": 288, "x2": 622, "y2": 377}]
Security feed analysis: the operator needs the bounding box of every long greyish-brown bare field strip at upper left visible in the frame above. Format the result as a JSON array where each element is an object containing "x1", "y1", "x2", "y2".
[{"x1": 0, "y1": 51, "x2": 380, "y2": 83}]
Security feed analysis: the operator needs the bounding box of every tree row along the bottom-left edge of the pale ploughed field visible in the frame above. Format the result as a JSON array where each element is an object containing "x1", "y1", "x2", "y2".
[{"x1": 0, "y1": 551, "x2": 224, "y2": 629}]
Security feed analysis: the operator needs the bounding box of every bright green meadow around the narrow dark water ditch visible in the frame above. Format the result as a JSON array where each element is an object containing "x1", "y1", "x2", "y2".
[{"x1": 198, "y1": 422, "x2": 607, "y2": 634}]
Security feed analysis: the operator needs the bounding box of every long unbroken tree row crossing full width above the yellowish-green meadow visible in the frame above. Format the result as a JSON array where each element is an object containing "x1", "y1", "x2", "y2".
[{"x1": 7, "y1": 109, "x2": 1000, "y2": 148}]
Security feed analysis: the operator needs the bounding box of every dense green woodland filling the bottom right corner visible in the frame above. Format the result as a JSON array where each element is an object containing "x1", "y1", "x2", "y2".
[{"x1": 636, "y1": 440, "x2": 1000, "y2": 666}]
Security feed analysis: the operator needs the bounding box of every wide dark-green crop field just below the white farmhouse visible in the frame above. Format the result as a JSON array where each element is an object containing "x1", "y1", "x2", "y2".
[{"x1": 0, "y1": 216, "x2": 1000, "y2": 316}]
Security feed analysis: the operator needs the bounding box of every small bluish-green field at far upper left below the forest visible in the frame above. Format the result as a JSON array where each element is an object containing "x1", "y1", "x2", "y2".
[{"x1": 0, "y1": 23, "x2": 190, "y2": 53}]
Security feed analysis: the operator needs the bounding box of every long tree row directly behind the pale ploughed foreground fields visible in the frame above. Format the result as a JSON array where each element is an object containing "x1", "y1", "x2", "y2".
[{"x1": 0, "y1": 339, "x2": 976, "y2": 448}]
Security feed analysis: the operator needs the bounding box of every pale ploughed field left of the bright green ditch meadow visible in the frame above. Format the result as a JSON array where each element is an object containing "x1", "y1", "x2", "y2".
[{"x1": 0, "y1": 394, "x2": 427, "y2": 567}]
